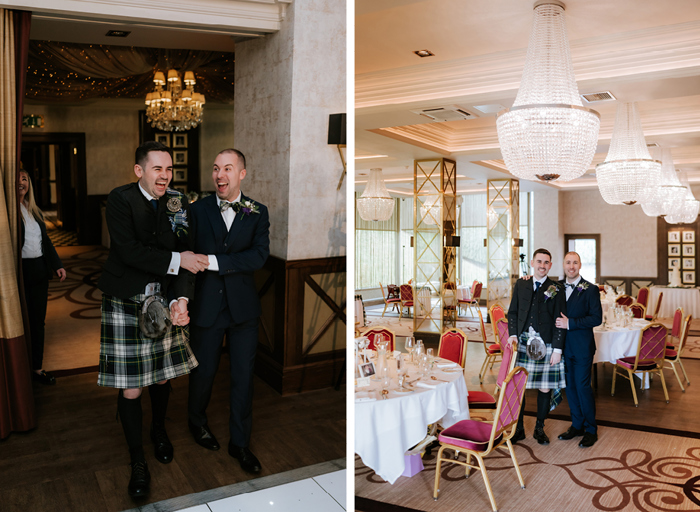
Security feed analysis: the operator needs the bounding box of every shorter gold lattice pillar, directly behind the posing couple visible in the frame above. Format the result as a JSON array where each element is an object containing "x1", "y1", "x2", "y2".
[{"x1": 482, "y1": 179, "x2": 520, "y2": 308}]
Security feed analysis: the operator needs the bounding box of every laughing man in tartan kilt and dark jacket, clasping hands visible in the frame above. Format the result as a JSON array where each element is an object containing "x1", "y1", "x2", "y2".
[{"x1": 97, "y1": 141, "x2": 208, "y2": 498}]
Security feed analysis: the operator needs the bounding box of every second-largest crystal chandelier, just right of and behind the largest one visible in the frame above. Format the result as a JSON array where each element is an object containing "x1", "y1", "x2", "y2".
[{"x1": 595, "y1": 103, "x2": 661, "y2": 205}]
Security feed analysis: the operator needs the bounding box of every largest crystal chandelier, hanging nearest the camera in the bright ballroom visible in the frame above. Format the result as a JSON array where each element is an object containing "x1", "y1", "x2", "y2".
[{"x1": 496, "y1": 0, "x2": 600, "y2": 181}]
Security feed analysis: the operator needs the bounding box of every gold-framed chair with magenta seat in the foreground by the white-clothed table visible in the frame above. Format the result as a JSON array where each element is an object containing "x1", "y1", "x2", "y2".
[{"x1": 433, "y1": 366, "x2": 528, "y2": 511}]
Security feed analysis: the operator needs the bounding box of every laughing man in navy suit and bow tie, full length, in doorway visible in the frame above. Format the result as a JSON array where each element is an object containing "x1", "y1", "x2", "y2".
[{"x1": 188, "y1": 149, "x2": 270, "y2": 473}]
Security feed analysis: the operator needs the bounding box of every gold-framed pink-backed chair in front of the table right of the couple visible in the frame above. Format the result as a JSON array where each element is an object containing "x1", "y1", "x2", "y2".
[{"x1": 610, "y1": 323, "x2": 669, "y2": 407}]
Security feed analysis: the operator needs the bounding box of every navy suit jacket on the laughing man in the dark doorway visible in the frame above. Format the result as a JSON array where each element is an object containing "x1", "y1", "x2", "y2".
[{"x1": 189, "y1": 194, "x2": 270, "y2": 327}]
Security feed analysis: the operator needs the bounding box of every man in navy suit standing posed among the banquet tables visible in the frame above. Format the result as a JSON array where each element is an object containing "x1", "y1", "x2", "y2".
[{"x1": 556, "y1": 252, "x2": 603, "y2": 448}]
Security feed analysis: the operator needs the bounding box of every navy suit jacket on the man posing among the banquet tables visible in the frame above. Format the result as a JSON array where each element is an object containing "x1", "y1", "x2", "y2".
[{"x1": 561, "y1": 278, "x2": 603, "y2": 357}]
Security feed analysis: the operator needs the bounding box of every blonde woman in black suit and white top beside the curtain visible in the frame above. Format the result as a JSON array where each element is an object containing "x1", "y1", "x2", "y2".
[{"x1": 18, "y1": 171, "x2": 66, "y2": 385}]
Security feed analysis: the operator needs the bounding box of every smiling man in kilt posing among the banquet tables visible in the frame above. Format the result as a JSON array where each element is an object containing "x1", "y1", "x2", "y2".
[{"x1": 508, "y1": 249, "x2": 566, "y2": 444}]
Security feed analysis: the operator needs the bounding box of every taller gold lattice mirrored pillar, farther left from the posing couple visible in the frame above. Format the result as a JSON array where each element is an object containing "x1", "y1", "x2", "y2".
[{"x1": 413, "y1": 158, "x2": 457, "y2": 336}]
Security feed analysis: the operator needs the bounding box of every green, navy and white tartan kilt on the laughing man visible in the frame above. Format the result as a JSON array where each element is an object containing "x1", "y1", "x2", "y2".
[{"x1": 97, "y1": 293, "x2": 199, "y2": 389}]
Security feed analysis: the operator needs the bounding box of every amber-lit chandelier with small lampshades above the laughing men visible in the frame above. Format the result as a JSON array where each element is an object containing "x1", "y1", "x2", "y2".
[{"x1": 146, "y1": 69, "x2": 206, "y2": 132}]
